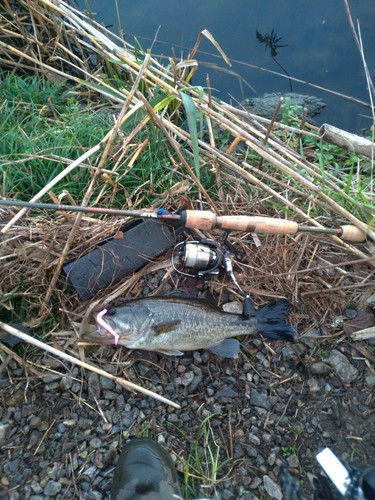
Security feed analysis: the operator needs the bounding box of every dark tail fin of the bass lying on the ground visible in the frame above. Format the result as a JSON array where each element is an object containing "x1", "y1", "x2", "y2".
[{"x1": 255, "y1": 299, "x2": 296, "y2": 340}]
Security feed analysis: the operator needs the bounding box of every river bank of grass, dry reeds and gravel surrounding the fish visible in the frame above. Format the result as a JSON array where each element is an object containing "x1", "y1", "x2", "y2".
[{"x1": 0, "y1": 1, "x2": 375, "y2": 500}]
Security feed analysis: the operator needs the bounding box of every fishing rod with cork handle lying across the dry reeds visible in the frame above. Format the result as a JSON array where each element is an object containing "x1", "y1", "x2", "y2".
[{"x1": 0, "y1": 199, "x2": 366, "y2": 242}]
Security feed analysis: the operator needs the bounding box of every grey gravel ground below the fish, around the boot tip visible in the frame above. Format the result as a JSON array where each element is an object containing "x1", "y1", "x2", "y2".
[{"x1": 0, "y1": 320, "x2": 375, "y2": 500}]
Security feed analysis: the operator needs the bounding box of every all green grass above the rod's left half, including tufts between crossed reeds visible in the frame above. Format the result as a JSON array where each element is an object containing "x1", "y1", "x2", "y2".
[{"x1": 0, "y1": 73, "x2": 181, "y2": 206}]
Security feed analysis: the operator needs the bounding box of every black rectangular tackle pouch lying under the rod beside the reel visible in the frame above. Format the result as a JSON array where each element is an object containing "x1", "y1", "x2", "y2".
[{"x1": 63, "y1": 219, "x2": 175, "y2": 301}]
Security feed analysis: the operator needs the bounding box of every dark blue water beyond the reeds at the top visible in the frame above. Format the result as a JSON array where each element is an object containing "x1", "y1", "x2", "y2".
[{"x1": 79, "y1": 0, "x2": 375, "y2": 133}]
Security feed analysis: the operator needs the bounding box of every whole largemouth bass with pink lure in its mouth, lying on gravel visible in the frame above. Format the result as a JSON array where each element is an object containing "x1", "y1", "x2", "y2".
[{"x1": 83, "y1": 297, "x2": 295, "y2": 358}]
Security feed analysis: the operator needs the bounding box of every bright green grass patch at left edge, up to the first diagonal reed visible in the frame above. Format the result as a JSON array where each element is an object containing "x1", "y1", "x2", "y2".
[{"x1": 0, "y1": 73, "x2": 112, "y2": 200}]
